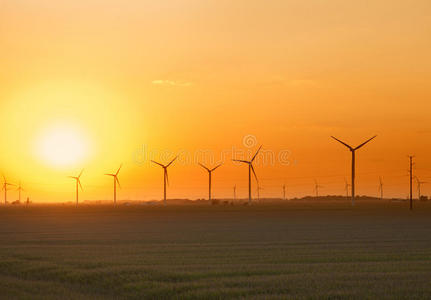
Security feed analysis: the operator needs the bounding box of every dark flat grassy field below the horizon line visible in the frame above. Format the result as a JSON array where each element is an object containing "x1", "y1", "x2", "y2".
[{"x1": 0, "y1": 202, "x2": 431, "y2": 299}]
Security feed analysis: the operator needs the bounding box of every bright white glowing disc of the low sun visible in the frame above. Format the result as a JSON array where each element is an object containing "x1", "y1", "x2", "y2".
[{"x1": 37, "y1": 126, "x2": 88, "y2": 167}]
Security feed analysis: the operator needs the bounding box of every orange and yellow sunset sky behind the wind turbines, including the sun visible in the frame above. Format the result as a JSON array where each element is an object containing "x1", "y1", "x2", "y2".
[{"x1": 0, "y1": 0, "x2": 431, "y2": 202}]
